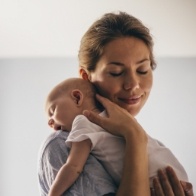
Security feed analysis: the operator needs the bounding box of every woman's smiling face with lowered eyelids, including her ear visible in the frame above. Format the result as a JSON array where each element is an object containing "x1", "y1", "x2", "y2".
[{"x1": 81, "y1": 37, "x2": 153, "y2": 116}]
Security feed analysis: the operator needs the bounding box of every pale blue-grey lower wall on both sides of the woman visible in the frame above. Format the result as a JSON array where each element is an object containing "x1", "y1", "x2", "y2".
[{"x1": 0, "y1": 58, "x2": 196, "y2": 196}]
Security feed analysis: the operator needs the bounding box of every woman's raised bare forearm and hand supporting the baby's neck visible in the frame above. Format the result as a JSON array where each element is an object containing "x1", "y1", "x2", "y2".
[{"x1": 84, "y1": 96, "x2": 150, "y2": 196}]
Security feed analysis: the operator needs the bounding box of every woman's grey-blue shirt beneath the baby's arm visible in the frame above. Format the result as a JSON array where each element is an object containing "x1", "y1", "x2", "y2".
[{"x1": 38, "y1": 131, "x2": 116, "y2": 196}]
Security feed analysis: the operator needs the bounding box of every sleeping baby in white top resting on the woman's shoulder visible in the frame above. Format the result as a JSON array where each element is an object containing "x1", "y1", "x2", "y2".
[{"x1": 45, "y1": 78, "x2": 188, "y2": 196}]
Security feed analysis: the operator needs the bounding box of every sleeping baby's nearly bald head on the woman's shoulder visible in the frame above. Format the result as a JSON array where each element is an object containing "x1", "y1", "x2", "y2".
[{"x1": 45, "y1": 78, "x2": 96, "y2": 131}]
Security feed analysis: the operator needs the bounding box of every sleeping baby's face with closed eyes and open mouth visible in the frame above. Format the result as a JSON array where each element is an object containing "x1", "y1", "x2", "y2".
[{"x1": 46, "y1": 95, "x2": 78, "y2": 131}]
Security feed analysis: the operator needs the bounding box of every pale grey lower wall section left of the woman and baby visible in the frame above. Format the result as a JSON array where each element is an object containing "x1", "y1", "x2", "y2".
[{"x1": 0, "y1": 59, "x2": 78, "y2": 196}]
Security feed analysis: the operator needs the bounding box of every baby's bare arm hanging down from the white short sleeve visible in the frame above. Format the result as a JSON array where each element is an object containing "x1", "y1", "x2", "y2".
[{"x1": 49, "y1": 139, "x2": 91, "y2": 196}]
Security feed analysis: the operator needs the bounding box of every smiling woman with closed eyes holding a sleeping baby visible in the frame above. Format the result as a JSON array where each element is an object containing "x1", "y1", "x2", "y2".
[{"x1": 39, "y1": 13, "x2": 192, "y2": 196}]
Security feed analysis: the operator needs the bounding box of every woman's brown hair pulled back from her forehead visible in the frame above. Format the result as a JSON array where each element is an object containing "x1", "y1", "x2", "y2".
[{"x1": 78, "y1": 12, "x2": 156, "y2": 71}]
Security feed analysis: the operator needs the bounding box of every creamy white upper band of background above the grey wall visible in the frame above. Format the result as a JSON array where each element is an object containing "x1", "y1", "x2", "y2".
[{"x1": 0, "y1": 0, "x2": 196, "y2": 58}]
